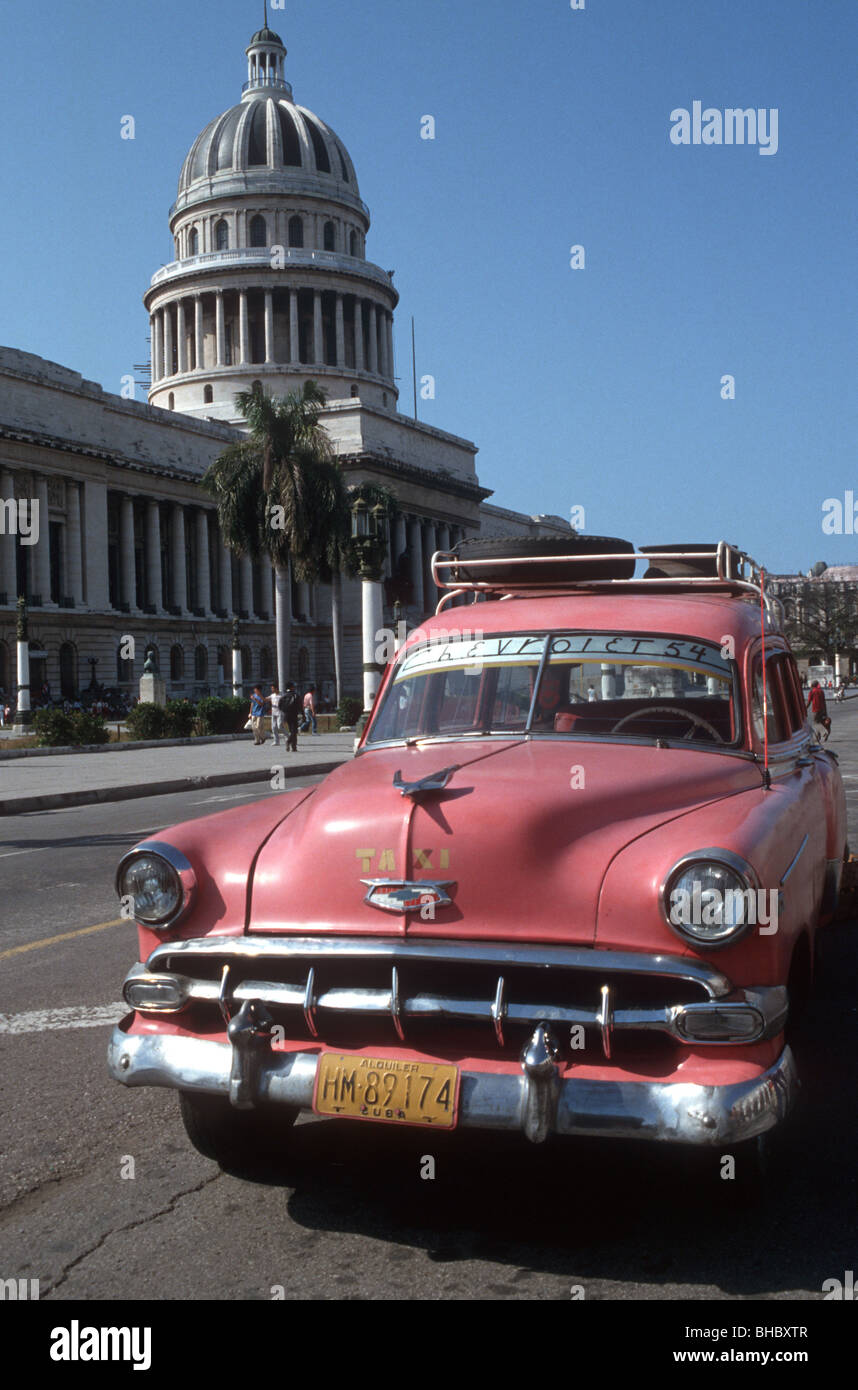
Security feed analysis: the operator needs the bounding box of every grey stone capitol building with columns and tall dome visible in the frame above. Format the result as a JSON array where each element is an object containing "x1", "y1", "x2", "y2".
[{"x1": 0, "y1": 25, "x2": 569, "y2": 699}]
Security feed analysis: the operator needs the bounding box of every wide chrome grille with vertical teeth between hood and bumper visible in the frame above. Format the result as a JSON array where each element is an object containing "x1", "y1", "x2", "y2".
[{"x1": 140, "y1": 937, "x2": 733, "y2": 1058}]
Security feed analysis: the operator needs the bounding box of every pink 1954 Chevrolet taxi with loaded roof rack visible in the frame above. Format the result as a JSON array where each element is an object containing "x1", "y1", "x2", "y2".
[{"x1": 110, "y1": 538, "x2": 845, "y2": 1166}]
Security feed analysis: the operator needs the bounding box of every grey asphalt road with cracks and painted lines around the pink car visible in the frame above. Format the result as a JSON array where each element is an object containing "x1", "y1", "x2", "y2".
[{"x1": 0, "y1": 717, "x2": 858, "y2": 1301}]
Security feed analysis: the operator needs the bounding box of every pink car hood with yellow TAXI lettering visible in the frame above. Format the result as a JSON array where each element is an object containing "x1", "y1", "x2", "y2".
[{"x1": 249, "y1": 739, "x2": 761, "y2": 944}]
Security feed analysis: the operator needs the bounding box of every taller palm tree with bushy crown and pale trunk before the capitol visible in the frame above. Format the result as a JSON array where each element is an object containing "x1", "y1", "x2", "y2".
[{"x1": 202, "y1": 381, "x2": 348, "y2": 688}]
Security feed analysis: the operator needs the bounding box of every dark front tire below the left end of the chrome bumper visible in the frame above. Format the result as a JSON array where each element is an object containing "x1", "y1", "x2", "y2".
[{"x1": 179, "y1": 1091, "x2": 298, "y2": 1173}]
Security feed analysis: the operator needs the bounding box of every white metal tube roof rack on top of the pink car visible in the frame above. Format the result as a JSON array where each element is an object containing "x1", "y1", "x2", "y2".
[{"x1": 431, "y1": 541, "x2": 784, "y2": 631}]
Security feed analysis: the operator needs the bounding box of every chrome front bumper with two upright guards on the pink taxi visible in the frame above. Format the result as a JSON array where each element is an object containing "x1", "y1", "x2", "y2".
[{"x1": 108, "y1": 1015, "x2": 798, "y2": 1145}]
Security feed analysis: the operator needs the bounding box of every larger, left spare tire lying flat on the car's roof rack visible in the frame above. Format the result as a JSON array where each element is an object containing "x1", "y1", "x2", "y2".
[{"x1": 445, "y1": 535, "x2": 634, "y2": 588}]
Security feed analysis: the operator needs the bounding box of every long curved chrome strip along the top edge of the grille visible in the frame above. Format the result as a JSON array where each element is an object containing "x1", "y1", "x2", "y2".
[{"x1": 146, "y1": 933, "x2": 733, "y2": 999}]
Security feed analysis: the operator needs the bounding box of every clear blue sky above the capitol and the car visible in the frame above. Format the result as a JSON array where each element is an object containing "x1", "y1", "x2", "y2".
[{"x1": 0, "y1": 0, "x2": 858, "y2": 571}]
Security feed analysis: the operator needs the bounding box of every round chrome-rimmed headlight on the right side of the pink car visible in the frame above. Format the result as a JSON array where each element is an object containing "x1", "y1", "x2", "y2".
[{"x1": 662, "y1": 849, "x2": 759, "y2": 949}]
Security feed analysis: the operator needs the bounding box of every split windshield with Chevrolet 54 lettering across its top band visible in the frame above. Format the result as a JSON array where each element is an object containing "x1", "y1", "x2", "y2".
[{"x1": 367, "y1": 632, "x2": 740, "y2": 745}]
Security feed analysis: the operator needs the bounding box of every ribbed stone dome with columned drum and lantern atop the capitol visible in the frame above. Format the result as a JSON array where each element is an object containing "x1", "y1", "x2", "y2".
[{"x1": 143, "y1": 24, "x2": 399, "y2": 423}]
